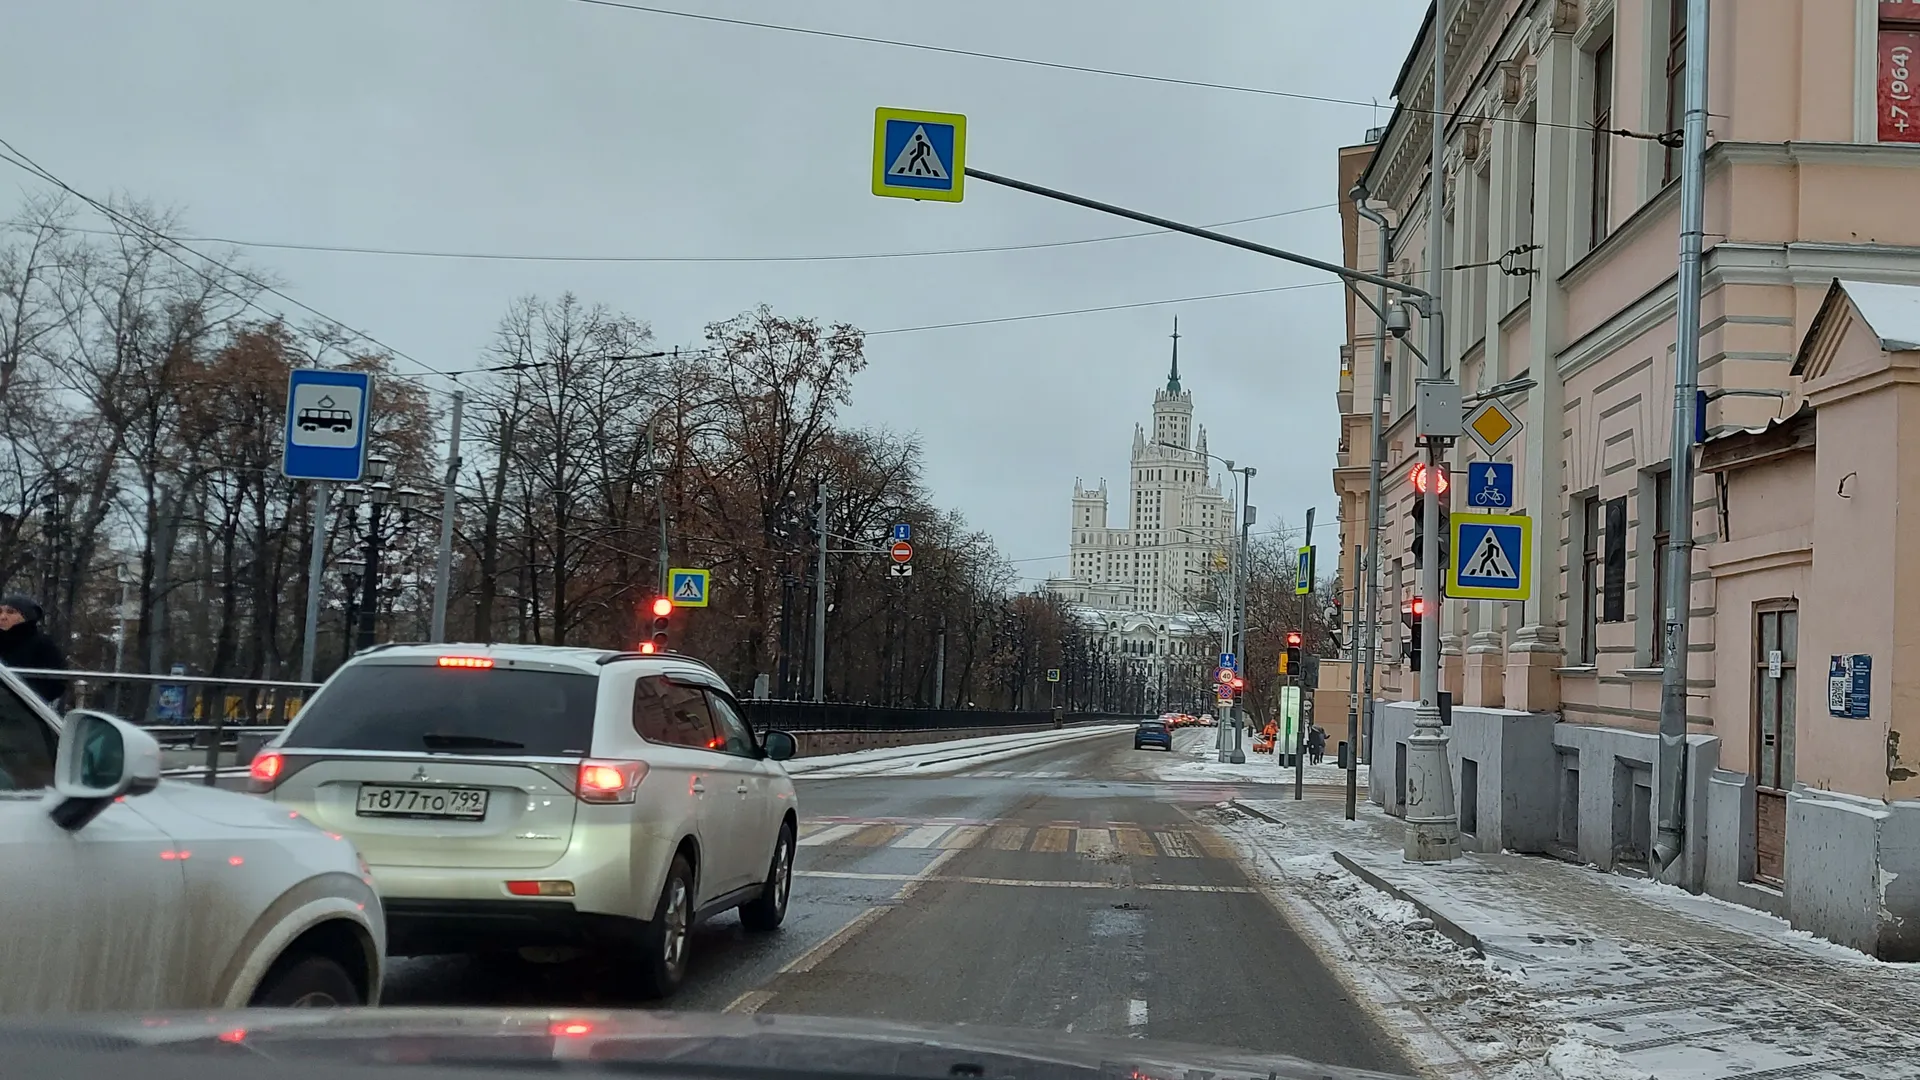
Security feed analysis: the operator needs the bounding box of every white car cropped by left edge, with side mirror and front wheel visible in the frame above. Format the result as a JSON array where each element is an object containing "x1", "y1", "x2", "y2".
[{"x1": 0, "y1": 671, "x2": 386, "y2": 1013}]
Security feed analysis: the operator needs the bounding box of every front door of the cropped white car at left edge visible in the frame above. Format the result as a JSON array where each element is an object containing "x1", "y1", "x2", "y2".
[{"x1": 0, "y1": 682, "x2": 186, "y2": 1013}]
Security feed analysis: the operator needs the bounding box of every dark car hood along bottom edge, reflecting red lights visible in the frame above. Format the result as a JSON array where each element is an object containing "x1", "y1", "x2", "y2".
[{"x1": 0, "y1": 1009, "x2": 1413, "y2": 1080}]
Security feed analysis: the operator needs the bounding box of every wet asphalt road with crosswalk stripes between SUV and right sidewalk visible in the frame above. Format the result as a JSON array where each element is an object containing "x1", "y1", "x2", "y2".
[{"x1": 384, "y1": 730, "x2": 1411, "y2": 1072}]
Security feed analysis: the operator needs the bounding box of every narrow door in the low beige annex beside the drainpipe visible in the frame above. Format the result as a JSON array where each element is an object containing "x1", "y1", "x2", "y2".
[{"x1": 1753, "y1": 601, "x2": 1799, "y2": 886}]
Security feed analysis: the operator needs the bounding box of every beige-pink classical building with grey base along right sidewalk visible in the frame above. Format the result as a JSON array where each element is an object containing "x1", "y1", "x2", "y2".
[{"x1": 1334, "y1": 0, "x2": 1920, "y2": 957}]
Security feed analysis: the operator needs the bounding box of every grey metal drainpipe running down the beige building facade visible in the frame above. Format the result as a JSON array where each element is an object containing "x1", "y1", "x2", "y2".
[{"x1": 1653, "y1": 0, "x2": 1709, "y2": 871}]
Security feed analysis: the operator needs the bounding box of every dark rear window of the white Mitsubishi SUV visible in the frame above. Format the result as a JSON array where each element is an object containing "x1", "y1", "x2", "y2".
[{"x1": 286, "y1": 663, "x2": 599, "y2": 757}]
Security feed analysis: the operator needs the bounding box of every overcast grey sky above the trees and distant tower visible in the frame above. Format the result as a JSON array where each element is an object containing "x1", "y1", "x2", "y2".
[{"x1": 0, "y1": 0, "x2": 1427, "y2": 582}]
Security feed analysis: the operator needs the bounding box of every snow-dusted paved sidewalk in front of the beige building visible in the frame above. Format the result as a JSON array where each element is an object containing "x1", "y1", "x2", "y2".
[{"x1": 1217, "y1": 799, "x2": 1920, "y2": 1080}]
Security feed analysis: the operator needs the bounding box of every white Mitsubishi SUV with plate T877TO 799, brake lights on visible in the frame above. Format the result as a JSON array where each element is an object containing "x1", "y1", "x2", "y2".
[{"x1": 252, "y1": 646, "x2": 799, "y2": 995}]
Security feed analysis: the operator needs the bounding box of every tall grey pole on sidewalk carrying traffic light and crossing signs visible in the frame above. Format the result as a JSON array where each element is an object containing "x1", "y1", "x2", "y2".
[{"x1": 1402, "y1": 0, "x2": 1461, "y2": 863}]
